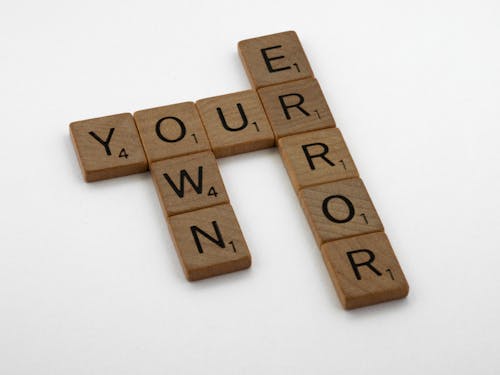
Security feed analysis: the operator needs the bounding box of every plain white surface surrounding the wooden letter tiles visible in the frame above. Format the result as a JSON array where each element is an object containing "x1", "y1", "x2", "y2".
[{"x1": 0, "y1": 0, "x2": 500, "y2": 375}]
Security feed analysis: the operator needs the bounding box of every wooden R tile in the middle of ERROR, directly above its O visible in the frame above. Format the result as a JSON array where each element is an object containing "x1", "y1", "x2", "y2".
[{"x1": 278, "y1": 128, "x2": 358, "y2": 193}]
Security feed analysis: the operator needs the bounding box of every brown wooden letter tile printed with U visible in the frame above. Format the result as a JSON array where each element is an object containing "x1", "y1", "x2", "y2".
[{"x1": 196, "y1": 90, "x2": 274, "y2": 158}]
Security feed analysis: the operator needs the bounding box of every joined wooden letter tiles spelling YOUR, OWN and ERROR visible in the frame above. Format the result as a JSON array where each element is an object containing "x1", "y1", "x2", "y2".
[{"x1": 70, "y1": 31, "x2": 408, "y2": 309}]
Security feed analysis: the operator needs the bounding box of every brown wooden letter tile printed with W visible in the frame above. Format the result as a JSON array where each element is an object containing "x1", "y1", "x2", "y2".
[{"x1": 151, "y1": 151, "x2": 229, "y2": 217}]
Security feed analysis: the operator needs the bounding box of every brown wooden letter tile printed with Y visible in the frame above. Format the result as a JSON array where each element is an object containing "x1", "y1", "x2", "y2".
[{"x1": 69, "y1": 113, "x2": 148, "y2": 182}]
